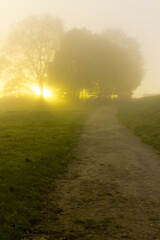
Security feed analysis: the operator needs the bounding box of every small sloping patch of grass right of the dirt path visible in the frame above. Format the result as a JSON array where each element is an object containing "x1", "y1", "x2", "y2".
[{"x1": 119, "y1": 96, "x2": 160, "y2": 152}]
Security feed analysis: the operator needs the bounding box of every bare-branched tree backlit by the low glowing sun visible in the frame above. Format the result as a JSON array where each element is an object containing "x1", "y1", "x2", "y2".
[{"x1": 6, "y1": 15, "x2": 63, "y2": 97}]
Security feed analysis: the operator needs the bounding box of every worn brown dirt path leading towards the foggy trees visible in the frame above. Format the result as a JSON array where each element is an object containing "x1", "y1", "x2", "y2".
[{"x1": 30, "y1": 107, "x2": 160, "y2": 240}]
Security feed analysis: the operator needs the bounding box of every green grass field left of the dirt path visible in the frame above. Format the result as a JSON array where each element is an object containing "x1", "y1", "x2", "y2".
[{"x1": 0, "y1": 98, "x2": 88, "y2": 240}]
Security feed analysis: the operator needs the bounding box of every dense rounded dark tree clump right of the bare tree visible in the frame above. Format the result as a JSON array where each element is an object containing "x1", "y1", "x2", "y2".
[{"x1": 50, "y1": 29, "x2": 143, "y2": 98}]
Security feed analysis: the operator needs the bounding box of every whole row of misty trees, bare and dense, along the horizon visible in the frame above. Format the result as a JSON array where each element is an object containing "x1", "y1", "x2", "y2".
[{"x1": 0, "y1": 15, "x2": 144, "y2": 99}]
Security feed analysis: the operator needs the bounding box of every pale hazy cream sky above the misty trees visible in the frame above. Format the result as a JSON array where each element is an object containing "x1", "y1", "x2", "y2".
[{"x1": 0, "y1": 0, "x2": 160, "y2": 97}]
